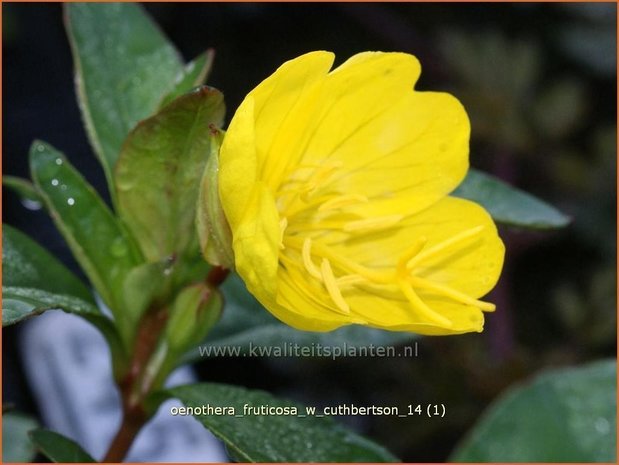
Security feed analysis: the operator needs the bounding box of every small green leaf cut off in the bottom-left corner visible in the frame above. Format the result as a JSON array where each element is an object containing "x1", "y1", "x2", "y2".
[{"x1": 2, "y1": 412, "x2": 39, "y2": 463}]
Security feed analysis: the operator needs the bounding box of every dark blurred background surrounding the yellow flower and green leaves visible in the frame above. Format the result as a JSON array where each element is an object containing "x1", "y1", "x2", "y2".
[{"x1": 2, "y1": 3, "x2": 616, "y2": 461}]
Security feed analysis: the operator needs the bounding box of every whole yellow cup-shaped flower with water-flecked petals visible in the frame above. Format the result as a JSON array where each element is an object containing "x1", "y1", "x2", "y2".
[{"x1": 218, "y1": 51, "x2": 504, "y2": 335}]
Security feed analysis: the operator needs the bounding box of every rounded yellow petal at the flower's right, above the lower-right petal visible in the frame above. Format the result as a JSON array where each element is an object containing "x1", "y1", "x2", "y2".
[{"x1": 333, "y1": 92, "x2": 470, "y2": 217}]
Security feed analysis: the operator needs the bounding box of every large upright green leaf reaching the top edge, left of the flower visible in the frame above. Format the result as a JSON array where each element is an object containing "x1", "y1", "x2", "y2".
[{"x1": 65, "y1": 3, "x2": 183, "y2": 190}]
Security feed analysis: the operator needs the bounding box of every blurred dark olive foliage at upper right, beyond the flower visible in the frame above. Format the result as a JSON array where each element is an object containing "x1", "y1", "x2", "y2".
[{"x1": 441, "y1": 30, "x2": 586, "y2": 154}]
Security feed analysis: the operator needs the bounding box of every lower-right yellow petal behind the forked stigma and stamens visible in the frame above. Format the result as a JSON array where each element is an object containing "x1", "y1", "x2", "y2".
[{"x1": 322, "y1": 196, "x2": 505, "y2": 298}]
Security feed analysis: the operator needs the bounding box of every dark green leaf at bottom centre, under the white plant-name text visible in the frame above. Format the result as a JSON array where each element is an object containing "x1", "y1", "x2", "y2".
[{"x1": 167, "y1": 383, "x2": 398, "y2": 462}]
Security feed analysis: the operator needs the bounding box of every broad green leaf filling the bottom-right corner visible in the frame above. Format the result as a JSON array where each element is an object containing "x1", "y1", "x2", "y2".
[{"x1": 451, "y1": 360, "x2": 617, "y2": 463}]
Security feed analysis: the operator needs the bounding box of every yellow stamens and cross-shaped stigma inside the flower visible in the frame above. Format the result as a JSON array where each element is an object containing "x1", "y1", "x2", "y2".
[{"x1": 276, "y1": 162, "x2": 495, "y2": 320}]
